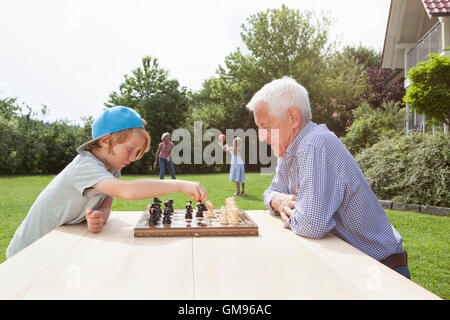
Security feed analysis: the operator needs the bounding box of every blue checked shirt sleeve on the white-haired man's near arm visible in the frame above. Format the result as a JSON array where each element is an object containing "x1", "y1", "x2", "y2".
[{"x1": 285, "y1": 146, "x2": 344, "y2": 239}]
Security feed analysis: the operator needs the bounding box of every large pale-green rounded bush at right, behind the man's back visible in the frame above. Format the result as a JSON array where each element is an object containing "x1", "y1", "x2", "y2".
[{"x1": 356, "y1": 133, "x2": 450, "y2": 207}]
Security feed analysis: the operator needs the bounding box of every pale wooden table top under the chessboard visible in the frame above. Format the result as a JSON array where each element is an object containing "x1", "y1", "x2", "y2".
[{"x1": 0, "y1": 210, "x2": 440, "y2": 300}]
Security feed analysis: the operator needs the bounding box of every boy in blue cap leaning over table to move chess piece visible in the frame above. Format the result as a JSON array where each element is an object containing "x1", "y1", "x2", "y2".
[{"x1": 6, "y1": 106, "x2": 207, "y2": 259}]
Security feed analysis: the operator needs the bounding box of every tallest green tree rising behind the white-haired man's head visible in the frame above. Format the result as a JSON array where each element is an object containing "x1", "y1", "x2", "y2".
[{"x1": 209, "y1": 5, "x2": 330, "y2": 129}]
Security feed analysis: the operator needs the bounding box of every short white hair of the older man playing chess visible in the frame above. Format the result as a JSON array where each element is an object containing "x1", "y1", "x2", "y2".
[{"x1": 246, "y1": 77, "x2": 312, "y2": 123}]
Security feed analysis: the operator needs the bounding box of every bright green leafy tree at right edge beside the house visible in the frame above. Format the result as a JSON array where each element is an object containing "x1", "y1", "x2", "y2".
[{"x1": 403, "y1": 52, "x2": 450, "y2": 125}]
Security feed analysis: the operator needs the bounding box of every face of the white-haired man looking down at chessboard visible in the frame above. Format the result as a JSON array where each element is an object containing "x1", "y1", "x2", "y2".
[{"x1": 253, "y1": 101, "x2": 292, "y2": 157}]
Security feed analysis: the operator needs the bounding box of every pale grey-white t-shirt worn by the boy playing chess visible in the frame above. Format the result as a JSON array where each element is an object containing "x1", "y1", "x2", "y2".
[{"x1": 6, "y1": 151, "x2": 120, "y2": 258}]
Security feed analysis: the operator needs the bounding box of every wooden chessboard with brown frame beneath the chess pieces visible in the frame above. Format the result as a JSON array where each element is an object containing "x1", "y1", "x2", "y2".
[{"x1": 134, "y1": 209, "x2": 258, "y2": 237}]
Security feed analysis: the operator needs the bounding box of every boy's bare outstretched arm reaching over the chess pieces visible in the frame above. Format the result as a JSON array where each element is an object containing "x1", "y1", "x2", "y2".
[{"x1": 93, "y1": 178, "x2": 208, "y2": 203}]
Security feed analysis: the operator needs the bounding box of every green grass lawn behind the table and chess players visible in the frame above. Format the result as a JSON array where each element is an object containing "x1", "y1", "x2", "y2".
[{"x1": 0, "y1": 173, "x2": 450, "y2": 300}]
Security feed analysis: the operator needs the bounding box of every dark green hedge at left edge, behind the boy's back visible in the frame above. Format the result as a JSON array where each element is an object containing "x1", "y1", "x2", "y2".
[{"x1": 0, "y1": 98, "x2": 92, "y2": 175}]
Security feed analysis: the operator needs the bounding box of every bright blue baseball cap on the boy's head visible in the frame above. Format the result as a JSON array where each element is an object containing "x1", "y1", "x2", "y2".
[{"x1": 77, "y1": 106, "x2": 144, "y2": 153}]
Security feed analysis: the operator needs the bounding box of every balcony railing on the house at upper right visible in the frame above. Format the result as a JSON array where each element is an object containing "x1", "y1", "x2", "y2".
[{"x1": 405, "y1": 22, "x2": 442, "y2": 74}]
